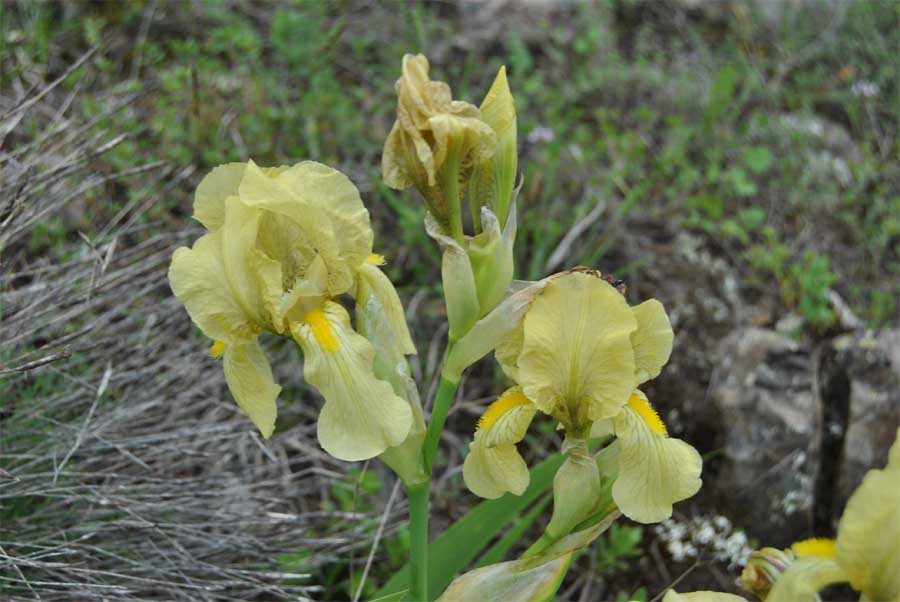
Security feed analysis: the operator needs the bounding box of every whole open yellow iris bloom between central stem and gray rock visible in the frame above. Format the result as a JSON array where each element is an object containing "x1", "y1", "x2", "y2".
[{"x1": 463, "y1": 270, "x2": 702, "y2": 530}]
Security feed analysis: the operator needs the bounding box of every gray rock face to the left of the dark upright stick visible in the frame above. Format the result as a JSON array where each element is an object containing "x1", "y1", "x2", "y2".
[{"x1": 707, "y1": 328, "x2": 817, "y2": 546}]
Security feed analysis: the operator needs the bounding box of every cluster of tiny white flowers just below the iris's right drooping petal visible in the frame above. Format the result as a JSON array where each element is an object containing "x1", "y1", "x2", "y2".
[{"x1": 654, "y1": 515, "x2": 752, "y2": 569}]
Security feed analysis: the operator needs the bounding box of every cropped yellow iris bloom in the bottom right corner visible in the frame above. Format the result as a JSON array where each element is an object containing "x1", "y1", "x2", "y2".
[{"x1": 742, "y1": 430, "x2": 900, "y2": 602}]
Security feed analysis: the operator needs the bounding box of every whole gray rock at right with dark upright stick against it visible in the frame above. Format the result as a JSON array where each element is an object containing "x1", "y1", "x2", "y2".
[{"x1": 706, "y1": 328, "x2": 900, "y2": 546}]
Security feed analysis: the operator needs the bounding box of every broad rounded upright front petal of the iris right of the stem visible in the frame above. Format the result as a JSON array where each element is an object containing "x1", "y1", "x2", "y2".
[{"x1": 518, "y1": 272, "x2": 637, "y2": 424}]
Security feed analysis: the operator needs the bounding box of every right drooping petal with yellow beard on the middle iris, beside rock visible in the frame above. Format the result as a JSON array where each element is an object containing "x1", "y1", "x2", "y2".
[{"x1": 612, "y1": 391, "x2": 703, "y2": 524}]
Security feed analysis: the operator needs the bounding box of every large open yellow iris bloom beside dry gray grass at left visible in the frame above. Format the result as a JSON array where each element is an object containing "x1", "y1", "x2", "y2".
[{"x1": 169, "y1": 161, "x2": 421, "y2": 460}]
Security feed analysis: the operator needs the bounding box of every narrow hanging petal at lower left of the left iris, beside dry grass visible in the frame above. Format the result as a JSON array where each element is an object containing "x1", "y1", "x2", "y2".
[{"x1": 222, "y1": 338, "x2": 281, "y2": 439}]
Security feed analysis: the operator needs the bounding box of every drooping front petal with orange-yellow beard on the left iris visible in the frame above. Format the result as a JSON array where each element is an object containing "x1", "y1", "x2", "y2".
[{"x1": 292, "y1": 301, "x2": 412, "y2": 461}]
